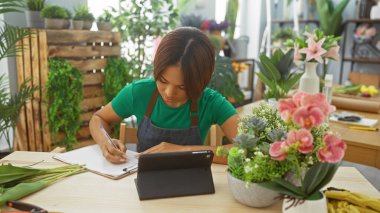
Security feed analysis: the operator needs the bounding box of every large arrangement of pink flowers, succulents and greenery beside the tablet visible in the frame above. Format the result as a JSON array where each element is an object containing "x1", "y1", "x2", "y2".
[{"x1": 217, "y1": 92, "x2": 346, "y2": 211}]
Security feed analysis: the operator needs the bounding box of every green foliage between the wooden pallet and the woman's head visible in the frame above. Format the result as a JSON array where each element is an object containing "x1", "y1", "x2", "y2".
[{"x1": 103, "y1": 57, "x2": 140, "y2": 103}]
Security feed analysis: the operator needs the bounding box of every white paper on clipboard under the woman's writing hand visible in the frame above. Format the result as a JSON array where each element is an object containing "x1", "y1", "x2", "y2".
[{"x1": 53, "y1": 144, "x2": 138, "y2": 179}]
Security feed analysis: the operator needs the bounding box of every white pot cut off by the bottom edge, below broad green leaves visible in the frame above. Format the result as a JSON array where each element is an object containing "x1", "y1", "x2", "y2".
[{"x1": 282, "y1": 193, "x2": 327, "y2": 213}]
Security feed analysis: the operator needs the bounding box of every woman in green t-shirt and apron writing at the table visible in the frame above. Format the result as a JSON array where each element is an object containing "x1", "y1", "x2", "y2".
[{"x1": 90, "y1": 28, "x2": 238, "y2": 163}]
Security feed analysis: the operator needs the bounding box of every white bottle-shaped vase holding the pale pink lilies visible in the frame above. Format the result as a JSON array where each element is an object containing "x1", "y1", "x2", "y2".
[{"x1": 299, "y1": 62, "x2": 319, "y2": 94}]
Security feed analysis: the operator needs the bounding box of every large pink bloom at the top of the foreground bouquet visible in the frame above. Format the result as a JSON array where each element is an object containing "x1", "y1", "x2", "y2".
[{"x1": 293, "y1": 107, "x2": 325, "y2": 130}]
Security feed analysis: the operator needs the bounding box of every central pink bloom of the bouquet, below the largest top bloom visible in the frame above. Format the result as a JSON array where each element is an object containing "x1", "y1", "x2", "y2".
[{"x1": 286, "y1": 129, "x2": 314, "y2": 154}]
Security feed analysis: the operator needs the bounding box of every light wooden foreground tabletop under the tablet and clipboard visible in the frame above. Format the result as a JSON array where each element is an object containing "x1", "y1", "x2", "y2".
[{"x1": 0, "y1": 151, "x2": 380, "y2": 213}]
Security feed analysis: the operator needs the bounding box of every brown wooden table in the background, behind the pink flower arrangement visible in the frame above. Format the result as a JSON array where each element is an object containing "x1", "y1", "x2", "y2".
[{"x1": 236, "y1": 102, "x2": 380, "y2": 169}]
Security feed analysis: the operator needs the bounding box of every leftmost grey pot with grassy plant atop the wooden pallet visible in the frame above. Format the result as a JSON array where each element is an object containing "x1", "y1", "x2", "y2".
[{"x1": 25, "y1": 0, "x2": 45, "y2": 29}]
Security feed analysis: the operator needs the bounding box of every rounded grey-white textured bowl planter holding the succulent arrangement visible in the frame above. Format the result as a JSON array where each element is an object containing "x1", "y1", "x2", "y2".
[{"x1": 227, "y1": 172, "x2": 279, "y2": 207}]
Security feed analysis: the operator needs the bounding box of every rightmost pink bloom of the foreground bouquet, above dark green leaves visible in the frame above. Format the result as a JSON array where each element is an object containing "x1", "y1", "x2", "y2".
[{"x1": 317, "y1": 134, "x2": 347, "y2": 163}]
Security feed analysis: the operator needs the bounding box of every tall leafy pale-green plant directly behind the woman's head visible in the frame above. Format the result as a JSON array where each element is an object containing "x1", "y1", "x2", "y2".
[{"x1": 111, "y1": 0, "x2": 178, "y2": 76}]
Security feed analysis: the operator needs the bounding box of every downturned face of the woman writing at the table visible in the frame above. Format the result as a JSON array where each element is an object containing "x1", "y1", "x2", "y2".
[{"x1": 157, "y1": 65, "x2": 188, "y2": 107}]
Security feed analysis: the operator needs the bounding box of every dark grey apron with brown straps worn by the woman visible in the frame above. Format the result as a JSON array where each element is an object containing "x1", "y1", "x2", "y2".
[{"x1": 137, "y1": 88, "x2": 202, "y2": 152}]
